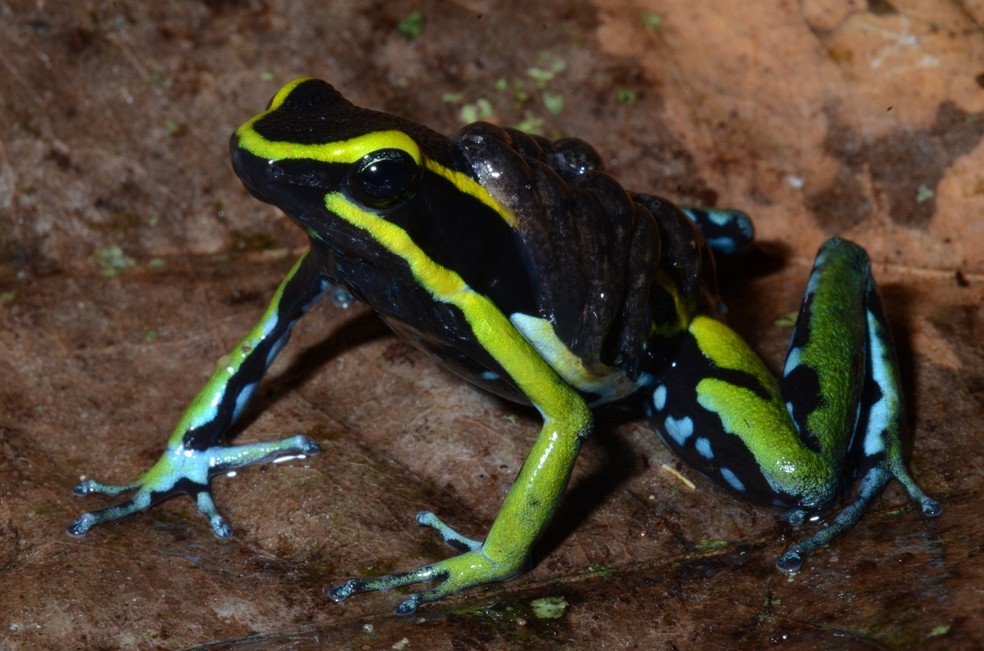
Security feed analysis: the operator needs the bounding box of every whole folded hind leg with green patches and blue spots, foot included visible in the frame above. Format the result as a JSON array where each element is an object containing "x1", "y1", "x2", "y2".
[{"x1": 645, "y1": 238, "x2": 940, "y2": 572}]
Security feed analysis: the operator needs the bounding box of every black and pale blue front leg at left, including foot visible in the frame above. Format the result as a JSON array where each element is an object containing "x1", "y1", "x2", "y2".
[{"x1": 68, "y1": 252, "x2": 330, "y2": 538}]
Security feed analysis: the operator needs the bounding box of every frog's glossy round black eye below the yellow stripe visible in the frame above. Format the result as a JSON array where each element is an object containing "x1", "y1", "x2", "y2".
[{"x1": 348, "y1": 149, "x2": 420, "y2": 208}]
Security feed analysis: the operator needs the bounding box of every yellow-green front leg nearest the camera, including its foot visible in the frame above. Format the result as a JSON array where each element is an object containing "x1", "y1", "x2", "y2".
[{"x1": 328, "y1": 291, "x2": 592, "y2": 615}]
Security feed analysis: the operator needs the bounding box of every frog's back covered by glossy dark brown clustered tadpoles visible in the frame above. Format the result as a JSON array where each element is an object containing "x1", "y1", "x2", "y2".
[{"x1": 458, "y1": 123, "x2": 716, "y2": 402}]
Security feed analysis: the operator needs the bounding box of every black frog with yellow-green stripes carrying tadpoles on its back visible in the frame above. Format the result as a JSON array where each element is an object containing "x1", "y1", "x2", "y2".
[{"x1": 68, "y1": 78, "x2": 941, "y2": 615}]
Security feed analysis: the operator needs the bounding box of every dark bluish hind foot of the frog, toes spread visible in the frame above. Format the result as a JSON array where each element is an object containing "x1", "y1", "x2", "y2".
[{"x1": 776, "y1": 463, "x2": 942, "y2": 574}]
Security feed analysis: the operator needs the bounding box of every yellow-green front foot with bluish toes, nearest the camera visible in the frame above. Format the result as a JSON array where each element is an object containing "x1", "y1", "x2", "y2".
[{"x1": 327, "y1": 511, "x2": 525, "y2": 615}]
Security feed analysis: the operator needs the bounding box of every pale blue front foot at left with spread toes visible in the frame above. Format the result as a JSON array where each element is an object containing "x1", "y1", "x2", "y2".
[{"x1": 68, "y1": 436, "x2": 319, "y2": 538}]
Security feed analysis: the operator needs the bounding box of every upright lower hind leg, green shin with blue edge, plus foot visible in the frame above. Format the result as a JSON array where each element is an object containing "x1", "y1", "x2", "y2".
[{"x1": 776, "y1": 238, "x2": 940, "y2": 572}]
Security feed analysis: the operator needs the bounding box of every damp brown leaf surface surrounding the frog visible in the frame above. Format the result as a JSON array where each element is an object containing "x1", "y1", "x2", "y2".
[{"x1": 0, "y1": 0, "x2": 984, "y2": 649}]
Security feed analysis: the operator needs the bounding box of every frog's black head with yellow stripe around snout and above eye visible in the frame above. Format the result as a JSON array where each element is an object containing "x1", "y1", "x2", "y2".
[{"x1": 230, "y1": 78, "x2": 460, "y2": 244}]
